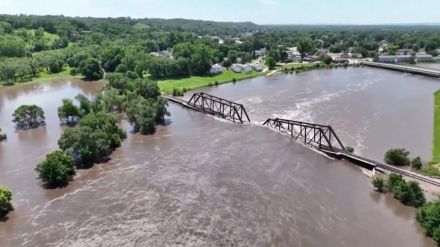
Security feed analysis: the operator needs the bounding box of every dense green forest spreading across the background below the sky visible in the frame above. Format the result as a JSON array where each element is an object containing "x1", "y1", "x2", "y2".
[{"x1": 0, "y1": 15, "x2": 440, "y2": 87}]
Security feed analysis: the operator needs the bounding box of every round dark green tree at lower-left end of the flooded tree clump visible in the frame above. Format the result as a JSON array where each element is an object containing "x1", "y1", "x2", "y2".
[{"x1": 35, "y1": 150, "x2": 75, "y2": 186}]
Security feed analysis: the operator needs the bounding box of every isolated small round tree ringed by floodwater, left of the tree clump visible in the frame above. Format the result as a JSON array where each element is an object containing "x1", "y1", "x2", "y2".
[{"x1": 12, "y1": 105, "x2": 45, "y2": 129}]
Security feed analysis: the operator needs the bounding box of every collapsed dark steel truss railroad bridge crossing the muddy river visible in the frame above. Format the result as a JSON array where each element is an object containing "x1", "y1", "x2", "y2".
[{"x1": 164, "y1": 93, "x2": 440, "y2": 187}]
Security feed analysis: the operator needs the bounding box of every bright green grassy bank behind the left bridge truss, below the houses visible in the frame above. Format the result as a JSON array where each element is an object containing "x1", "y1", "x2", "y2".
[{"x1": 158, "y1": 70, "x2": 264, "y2": 94}]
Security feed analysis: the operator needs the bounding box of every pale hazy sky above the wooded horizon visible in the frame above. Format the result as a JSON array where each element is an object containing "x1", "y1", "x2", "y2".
[{"x1": 0, "y1": 0, "x2": 440, "y2": 25}]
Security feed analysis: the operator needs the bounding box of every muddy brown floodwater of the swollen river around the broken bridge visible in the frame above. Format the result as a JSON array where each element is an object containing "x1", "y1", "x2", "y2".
[{"x1": 0, "y1": 68, "x2": 440, "y2": 246}]
